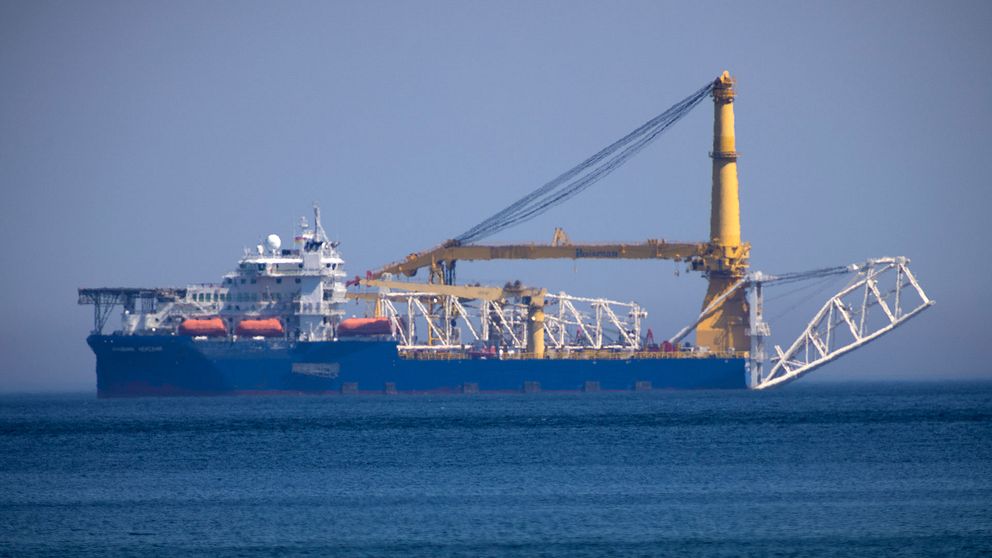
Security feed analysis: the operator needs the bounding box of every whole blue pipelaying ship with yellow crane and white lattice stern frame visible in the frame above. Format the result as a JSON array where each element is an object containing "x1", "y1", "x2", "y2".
[{"x1": 78, "y1": 72, "x2": 934, "y2": 397}]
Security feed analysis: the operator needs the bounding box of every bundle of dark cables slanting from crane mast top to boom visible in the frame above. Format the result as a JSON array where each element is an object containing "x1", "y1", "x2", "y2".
[{"x1": 454, "y1": 82, "x2": 714, "y2": 245}]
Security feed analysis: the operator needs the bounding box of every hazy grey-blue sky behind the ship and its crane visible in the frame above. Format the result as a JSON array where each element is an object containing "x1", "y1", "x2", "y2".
[{"x1": 0, "y1": 1, "x2": 992, "y2": 392}]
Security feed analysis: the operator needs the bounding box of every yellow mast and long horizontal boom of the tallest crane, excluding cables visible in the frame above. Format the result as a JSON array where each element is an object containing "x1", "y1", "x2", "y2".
[{"x1": 369, "y1": 72, "x2": 750, "y2": 351}]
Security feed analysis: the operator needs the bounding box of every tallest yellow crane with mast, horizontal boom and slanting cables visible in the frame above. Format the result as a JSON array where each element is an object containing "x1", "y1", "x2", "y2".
[{"x1": 367, "y1": 71, "x2": 751, "y2": 351}]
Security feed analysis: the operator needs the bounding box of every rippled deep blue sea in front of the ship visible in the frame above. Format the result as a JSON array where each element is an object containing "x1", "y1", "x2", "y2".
[{"x1": 0, "y1": 383, "x2": 992, "y2": 557}]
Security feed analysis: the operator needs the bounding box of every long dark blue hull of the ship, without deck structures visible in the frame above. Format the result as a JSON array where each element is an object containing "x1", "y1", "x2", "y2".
[{"x1": 87, "y1": 335, "x2": 747, "y2": 397}]
